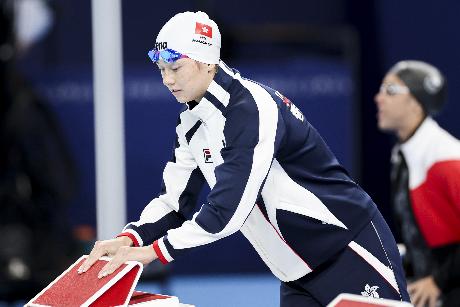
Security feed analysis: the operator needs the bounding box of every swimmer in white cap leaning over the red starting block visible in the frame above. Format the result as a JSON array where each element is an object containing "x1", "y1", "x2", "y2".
[{"x1": 79, "y1": 12, "x2": 409, "y2": 307}]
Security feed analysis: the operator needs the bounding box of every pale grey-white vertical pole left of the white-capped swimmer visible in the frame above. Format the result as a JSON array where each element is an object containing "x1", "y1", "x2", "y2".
[{"x1": 92, "y1": 0, "x2": 126, "y2": 239}]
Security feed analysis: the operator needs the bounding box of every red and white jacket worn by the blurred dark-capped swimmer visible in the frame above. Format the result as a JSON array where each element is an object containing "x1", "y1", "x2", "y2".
[{"x1": 394, "y1": 117, "x2": 460, "y2": 248}]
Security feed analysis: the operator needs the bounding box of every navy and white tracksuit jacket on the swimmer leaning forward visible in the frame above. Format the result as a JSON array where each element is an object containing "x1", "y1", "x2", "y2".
[{"x1": 120, "y1": 62, "x2": 402, "y2": 292}]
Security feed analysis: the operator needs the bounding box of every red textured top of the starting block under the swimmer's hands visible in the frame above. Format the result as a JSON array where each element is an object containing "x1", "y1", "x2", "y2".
[{"x1": 32, "y1": 259, "x2": 139, "y2": 307}]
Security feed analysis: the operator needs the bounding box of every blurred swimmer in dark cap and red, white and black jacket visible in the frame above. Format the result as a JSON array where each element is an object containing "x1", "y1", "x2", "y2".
[{"x1": 375, "y1": 61, "x2": 460, "y2": 307}]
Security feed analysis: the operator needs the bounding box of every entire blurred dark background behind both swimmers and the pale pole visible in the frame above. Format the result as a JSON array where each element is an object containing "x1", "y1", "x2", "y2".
[{"x1": 0, "y1": 0, "x2": 460, "y2": 307}]
